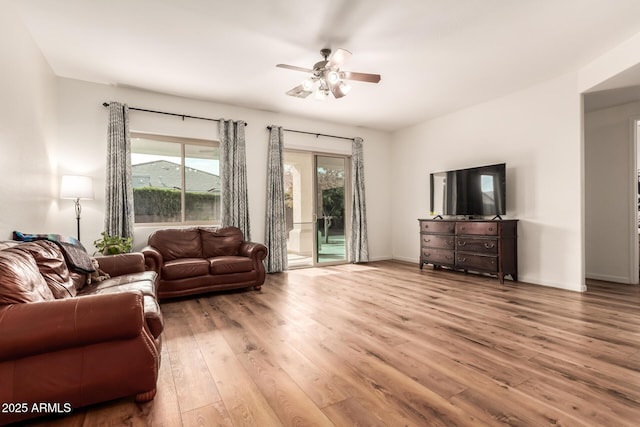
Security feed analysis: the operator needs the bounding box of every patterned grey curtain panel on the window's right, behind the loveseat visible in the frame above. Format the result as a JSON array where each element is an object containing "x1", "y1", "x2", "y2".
[{"x1": 218, "y1": 119, "x2": 251, "y2": 241}]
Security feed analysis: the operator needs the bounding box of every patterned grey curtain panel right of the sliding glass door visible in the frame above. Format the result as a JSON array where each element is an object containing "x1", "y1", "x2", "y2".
[{"x1": 349, "y1": 138, "x2": 369, "y2": 263}]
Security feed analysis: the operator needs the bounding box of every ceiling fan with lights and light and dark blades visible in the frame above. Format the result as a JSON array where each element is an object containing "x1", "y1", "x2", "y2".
[{"x1": 276, "y1": 49, "x2": 380, "y2": 99}]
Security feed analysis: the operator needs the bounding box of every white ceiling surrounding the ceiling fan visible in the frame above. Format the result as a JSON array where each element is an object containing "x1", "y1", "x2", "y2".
[{"x1": 15, "y1": 0, "x2": 640, "y2": 131}]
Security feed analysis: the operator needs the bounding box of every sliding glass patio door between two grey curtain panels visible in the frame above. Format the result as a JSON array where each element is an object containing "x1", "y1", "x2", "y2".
[{"x1": 284, "y1": 150, "x2": 350, "y2": 268}]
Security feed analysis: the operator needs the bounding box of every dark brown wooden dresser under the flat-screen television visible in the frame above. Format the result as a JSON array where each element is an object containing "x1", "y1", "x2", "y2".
[{"x1": 418, "y1": 219, "x2": 518, "y2": 283}]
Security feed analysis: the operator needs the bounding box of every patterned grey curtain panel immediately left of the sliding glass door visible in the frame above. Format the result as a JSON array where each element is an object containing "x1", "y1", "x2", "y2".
[{"x1": 265, "y1": 126, "x2": 287, "y2": 273}]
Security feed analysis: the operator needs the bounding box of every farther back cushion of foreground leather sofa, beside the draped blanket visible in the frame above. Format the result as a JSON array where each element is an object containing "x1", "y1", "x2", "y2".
[{"x1": 15, "y1": 240, "x2": 77, "y2": 299}]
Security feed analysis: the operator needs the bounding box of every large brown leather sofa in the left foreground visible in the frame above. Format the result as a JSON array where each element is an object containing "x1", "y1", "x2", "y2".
[{"x1": 0, "y1": 240, "x2": 163, "y2": 425}]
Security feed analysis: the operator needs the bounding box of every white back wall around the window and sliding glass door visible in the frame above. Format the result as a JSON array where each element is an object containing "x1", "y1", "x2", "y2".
[{"x1": 57, "y1": 79, "x2": 392, "y2": 260}]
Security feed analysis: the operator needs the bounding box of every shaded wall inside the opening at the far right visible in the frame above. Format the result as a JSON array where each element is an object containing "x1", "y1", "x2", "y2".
[{"x1": 584, "y1": 102, "x2": 640, "y2": 283}]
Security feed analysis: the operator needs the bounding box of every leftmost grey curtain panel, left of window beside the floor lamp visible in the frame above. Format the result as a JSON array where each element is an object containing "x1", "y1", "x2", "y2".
[{"x1": 104, "y1": 102, "x2": 133, "y2": 238}]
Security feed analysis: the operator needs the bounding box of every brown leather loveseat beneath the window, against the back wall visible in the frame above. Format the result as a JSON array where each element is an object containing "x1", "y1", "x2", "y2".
[{"x1": 142, "y1": 227, "x2": 267, "y2": 299}]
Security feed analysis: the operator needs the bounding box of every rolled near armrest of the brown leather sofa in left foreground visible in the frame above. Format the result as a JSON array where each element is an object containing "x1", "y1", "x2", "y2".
[{"x1": 0, "y1": 291, "x2": 145, "y2": 362}]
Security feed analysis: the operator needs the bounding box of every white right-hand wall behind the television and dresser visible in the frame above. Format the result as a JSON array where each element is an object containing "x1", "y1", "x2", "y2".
[{"x1": 391, "y1": 74, "x2": 584, "y2": 291}]
